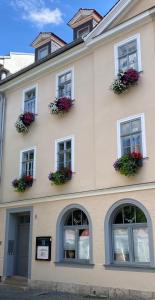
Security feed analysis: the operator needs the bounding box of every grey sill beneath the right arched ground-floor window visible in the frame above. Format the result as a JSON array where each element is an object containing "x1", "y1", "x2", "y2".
[{"x1": 103, "y1": 264, "x2": 155, "y2": 271}]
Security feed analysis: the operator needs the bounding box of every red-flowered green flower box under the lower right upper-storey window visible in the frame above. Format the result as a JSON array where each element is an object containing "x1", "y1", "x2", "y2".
[{"x1": 113, "y1": 152, "x2": 143, "y2": 176}]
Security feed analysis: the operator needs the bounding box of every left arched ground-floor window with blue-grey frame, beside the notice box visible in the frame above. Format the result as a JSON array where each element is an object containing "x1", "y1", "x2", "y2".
[{"x1": 57, "y1": 207, "x2": 91, "y2": 263}]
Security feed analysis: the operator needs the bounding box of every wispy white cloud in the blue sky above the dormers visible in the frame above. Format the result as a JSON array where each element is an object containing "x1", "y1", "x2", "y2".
[{"x1": 11, "y1": 0, "x2": 63, "y2": 27}]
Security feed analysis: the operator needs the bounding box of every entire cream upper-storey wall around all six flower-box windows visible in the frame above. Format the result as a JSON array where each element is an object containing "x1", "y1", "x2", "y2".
[{"x1": 2, "y1": 18, "x2": 155, "y2": 201}]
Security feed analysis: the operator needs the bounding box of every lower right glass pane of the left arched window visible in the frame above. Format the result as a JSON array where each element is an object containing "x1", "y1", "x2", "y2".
[{"x1": 78, "y1": 229, "x2": 90, "y2": 259}]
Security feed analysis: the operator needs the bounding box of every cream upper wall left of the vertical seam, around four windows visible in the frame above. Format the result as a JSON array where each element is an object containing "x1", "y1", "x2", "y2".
[{"x1": 3, "y1": 55, "x2": 95, "y2": 201}]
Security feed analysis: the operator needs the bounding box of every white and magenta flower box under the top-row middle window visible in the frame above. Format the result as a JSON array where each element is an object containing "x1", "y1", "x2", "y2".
[{"x1": 49, "y1": 97, "x2": 73, "y2": 114}]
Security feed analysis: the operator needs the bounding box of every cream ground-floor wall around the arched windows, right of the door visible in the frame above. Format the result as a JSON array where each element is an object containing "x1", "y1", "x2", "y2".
[{"x1": 28, "y1": 191, "x2": 155, "y2": 292}]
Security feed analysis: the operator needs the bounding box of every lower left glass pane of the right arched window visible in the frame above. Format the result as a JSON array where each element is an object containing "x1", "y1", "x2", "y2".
[{"x1": 113, "y1": 229, "x2": 130, "y2": 262}]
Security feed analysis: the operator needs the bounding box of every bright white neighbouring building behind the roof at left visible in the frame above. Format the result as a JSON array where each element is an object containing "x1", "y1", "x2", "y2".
[{"x1": 0, "y1": 52, "x2": 34, "y2": 80}]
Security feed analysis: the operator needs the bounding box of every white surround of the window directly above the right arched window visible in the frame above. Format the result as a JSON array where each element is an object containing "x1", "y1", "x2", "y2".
[{"x1": 117, "y1": 113, "x2": 147, "y2": 158}]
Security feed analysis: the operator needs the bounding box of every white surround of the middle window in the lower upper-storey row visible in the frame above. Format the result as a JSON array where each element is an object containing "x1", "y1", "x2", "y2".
[{"x1": 54, "y1": 135, "x2": 75, "y2": 172}]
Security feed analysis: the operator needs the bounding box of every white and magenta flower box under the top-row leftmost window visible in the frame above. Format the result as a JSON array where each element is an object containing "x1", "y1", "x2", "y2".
[{"x1": 15, "y1": 112, "x2": 35, "y2": 133}]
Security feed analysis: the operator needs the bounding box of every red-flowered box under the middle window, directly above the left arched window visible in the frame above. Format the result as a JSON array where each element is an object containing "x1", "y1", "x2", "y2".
[{"x1": 48, "y1": 168, "x2": 72, "y2": 185}]
